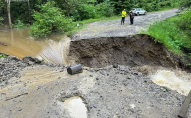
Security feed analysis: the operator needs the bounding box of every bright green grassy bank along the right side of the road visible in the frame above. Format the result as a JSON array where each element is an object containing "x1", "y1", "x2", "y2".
[{"x1": 142, "y1": 8, "x2": 191, "y2": 65}]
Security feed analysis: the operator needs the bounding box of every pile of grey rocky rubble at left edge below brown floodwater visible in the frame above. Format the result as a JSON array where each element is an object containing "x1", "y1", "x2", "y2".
[{"x1": 0, "y1": 56, "x2": 56, "y2": 87}]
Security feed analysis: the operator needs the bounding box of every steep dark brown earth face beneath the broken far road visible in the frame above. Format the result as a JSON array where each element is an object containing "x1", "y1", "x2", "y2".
[{"x1": 69, "y1": 34, "x2": 179, "y2": 67}]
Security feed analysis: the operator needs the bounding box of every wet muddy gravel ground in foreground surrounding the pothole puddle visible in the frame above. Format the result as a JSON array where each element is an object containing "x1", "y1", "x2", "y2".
[{"x1": 0, "y1": 62, "x2": 191, "y2": 118}]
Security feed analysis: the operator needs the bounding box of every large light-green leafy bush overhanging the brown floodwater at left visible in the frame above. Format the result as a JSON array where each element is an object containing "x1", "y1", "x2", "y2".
[{"x1": 31, "y1": 1, "x2": 73, "y2": 38}]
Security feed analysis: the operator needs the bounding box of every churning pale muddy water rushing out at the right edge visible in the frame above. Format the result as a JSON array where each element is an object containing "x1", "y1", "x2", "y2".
[{"x1": 151, "y1": 70, "x2": 191, "y2": 96}]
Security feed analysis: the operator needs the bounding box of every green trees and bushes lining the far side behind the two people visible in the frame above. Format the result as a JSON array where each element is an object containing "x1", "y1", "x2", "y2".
[{"x1": 0, "y1": 0, "x2": 189, "y2": 38}]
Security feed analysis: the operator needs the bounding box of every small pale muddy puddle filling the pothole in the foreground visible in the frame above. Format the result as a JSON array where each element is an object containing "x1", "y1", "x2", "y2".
[{"x1": 64, "y1": 97, "x2": 87, "y2": 118}]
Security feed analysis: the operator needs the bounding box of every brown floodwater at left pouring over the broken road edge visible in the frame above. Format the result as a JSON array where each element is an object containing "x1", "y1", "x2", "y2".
[{"x1": 0, "y1": 29, "x2": 70, "y2": 64}]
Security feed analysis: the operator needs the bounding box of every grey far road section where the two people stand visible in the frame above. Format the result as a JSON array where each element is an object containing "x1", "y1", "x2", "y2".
[{"x1": 72, "y1": 9, "x2": 178, "y2": 40}]
